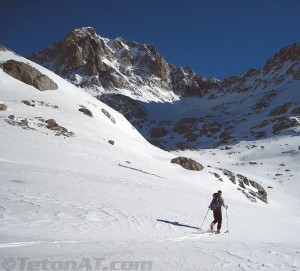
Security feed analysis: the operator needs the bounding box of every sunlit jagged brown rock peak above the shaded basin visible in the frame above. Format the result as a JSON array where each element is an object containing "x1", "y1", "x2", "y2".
[{"x1": 29, "y1": 27, "x2": 216, "y2": 101}]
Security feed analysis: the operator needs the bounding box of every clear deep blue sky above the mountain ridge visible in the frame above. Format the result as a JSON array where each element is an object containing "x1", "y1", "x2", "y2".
[{"x1": 0, "y1": 0, "x2": 300, "y2": 79}]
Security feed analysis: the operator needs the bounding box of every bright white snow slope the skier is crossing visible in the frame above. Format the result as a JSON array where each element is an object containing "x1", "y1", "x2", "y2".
[{"x1": 0, "y1": 51, "x2": 300, "y2": 270}]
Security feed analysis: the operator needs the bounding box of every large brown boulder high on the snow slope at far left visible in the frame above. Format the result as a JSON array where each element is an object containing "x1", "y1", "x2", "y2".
[{"x1": 2, "y1": 59, "x2": 58, "y2": 91}]
